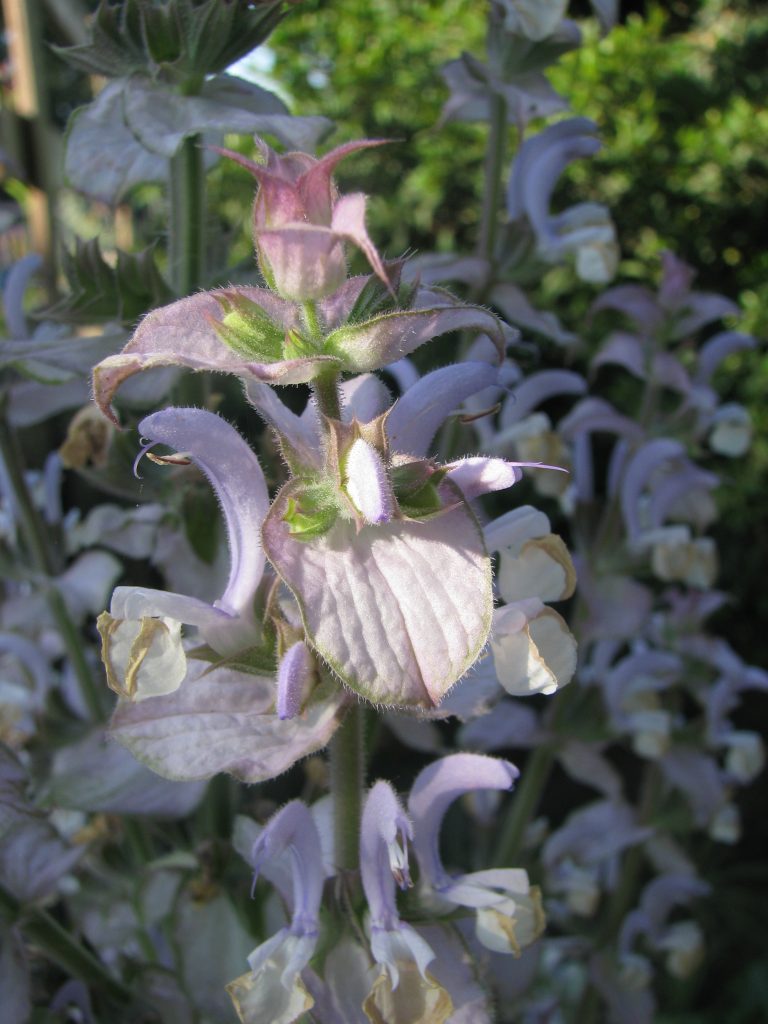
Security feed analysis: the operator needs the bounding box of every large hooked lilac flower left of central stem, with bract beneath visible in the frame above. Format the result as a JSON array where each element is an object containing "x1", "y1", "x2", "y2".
[{"x1": 98, "y1": 408, "x2": 347, "y2": 781}]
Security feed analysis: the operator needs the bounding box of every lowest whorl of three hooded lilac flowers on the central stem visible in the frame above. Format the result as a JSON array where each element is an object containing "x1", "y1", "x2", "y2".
[{"x1": 227, "y1": 754, "x2": 544, "y2": 1024}]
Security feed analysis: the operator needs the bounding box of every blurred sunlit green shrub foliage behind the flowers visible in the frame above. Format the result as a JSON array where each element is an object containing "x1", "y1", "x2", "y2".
[{"x1": 269, "y1": 0, "x2": 768, "y2": 665}]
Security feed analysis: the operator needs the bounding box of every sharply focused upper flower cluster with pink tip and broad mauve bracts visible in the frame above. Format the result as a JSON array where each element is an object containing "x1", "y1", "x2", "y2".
[{"x1": 94, "y1": 143, "x2": 574, "y2": 781}]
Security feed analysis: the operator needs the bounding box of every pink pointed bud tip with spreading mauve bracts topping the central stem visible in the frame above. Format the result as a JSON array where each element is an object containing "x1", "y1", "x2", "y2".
[{"x1": 93, "y1": 141, "x2": 513, "y2": 419}]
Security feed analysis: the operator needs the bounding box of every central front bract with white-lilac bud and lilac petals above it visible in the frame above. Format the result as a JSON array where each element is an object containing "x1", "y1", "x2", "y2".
[{"x1": 249, "y1": 372, "x2": 561, "y2": 708}]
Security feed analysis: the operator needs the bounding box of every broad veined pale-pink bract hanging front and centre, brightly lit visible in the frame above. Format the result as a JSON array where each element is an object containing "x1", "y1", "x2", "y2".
[{"x1": 263, "y1": 483, "x2": 493, "y2": 708}]
